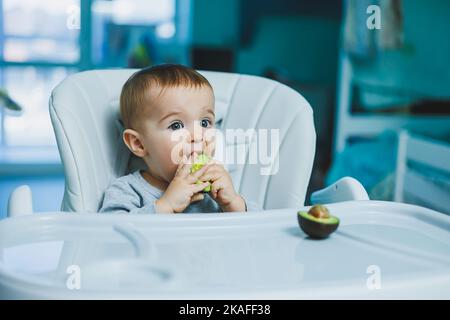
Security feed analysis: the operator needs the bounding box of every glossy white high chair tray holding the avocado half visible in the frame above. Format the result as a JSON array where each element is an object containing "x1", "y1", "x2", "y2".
[{"x1": 0, "y1": 201, "x2": 450, "y2": 299}]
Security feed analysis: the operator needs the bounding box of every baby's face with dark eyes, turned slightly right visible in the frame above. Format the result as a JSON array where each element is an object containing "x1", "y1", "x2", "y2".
[{"x1": 140, "y1": 86, "x2": 215, "y2": 182}]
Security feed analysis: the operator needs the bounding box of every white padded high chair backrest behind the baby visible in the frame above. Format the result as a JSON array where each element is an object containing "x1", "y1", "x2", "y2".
[{"x1": 49, "y1": 69, "x2": 316, "y2": 212}]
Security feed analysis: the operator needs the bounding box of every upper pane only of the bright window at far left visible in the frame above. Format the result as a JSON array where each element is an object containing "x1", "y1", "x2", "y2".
[{"x1": 2, "y1": 0, "x2": 80, "y2": 63}]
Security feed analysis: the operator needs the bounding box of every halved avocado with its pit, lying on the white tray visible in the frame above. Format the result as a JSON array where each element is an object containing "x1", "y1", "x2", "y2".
[{"x1": 297, "y1": 204, "x2": 339, "y2": 239}]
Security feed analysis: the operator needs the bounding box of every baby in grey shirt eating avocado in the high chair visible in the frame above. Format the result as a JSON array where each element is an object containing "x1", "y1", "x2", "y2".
[{"x1": 100, "y1": 64, "x2": 251, "y2": 213}]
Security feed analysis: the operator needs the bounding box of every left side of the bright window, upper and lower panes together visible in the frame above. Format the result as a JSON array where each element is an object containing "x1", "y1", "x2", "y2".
[{"x1": 0, "y1": 0, "x2": 80, "y2": 147}]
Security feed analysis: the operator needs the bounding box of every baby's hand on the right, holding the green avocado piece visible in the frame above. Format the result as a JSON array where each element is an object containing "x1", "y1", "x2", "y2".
[{"x1": 199, "y1": 161, "x2": 246, "y2": 212}]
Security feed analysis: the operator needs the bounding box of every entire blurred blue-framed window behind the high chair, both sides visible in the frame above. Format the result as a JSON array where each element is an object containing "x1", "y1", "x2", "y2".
[{"x1": 0, "y1": 0, "x2": 190, "y2": 149}]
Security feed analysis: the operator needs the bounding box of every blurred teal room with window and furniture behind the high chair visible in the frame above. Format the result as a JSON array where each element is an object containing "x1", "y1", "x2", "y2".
[{"x1": 0, "y1": 0, "x2": 450, "y2": 218}]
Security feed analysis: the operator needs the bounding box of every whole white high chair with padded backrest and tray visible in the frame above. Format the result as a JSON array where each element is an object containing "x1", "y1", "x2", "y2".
[{"x1": 5, "y1": 70, "x2": 450, "y2": 300}]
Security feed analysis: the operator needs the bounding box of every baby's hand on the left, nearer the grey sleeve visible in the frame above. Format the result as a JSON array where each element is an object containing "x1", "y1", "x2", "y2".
[{"x1": 155, "y1": 156, "x2": 209, "y2": 213}]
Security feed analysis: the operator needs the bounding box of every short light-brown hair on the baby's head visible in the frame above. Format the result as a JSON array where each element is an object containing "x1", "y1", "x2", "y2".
[{"x1": 120, "y1": 64, "x2": 212, "y2": 128}]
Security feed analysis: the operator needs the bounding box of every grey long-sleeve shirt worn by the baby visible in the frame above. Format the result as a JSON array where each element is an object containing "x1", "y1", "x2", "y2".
[{"x1": 99, "y1": 170, "x2": 259, "y2": 213}]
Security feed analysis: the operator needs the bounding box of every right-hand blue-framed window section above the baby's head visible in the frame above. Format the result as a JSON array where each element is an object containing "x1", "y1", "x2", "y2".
[{"x1": 91, "y1": 0, "x2": 179, "y2": 67}]
